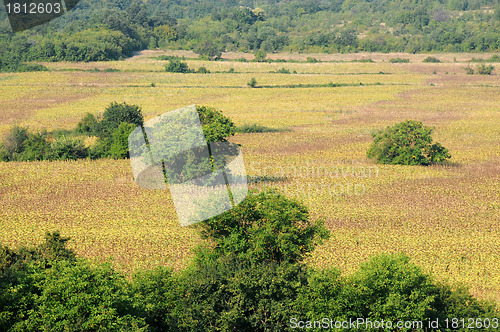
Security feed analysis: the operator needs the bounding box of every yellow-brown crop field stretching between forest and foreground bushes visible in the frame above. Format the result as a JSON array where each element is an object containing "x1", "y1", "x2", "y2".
[{"x1": 0, "y1": 52, "x2": 500, "y2": 303}]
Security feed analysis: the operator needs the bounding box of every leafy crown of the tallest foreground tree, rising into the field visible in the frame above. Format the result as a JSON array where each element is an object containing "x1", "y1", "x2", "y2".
[{"x1": 202, "y1": 191, "x2": 328, "y2": 263}]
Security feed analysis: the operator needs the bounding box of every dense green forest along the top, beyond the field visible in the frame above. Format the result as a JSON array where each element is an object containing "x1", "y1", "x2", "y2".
[{"x1": 0, "y1": 0, "x2": 500, "y2": 70}]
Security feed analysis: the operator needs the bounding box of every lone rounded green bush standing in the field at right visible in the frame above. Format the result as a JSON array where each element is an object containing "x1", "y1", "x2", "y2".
[{"x1": 367, "y1": 120, "x2": 451, "y2": 165}]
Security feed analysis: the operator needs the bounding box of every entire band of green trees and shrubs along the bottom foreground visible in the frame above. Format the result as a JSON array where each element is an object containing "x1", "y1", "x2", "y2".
[{"x1": 0, "y1": 191, "x2": 499, "y2": 331}]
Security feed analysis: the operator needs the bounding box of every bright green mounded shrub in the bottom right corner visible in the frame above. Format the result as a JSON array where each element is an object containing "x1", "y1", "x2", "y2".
[{"x1": 297, "y1": 254, "x2": 498, "y2": 331}]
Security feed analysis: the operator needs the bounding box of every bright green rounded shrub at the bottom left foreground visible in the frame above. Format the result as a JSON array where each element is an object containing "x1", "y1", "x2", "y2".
[{"x1": 14, "y1": 260, "x2": 146, "y2": 331}]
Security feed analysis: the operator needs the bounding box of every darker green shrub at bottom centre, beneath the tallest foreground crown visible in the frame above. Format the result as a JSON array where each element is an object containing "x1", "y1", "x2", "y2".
[{"x1": 171, "y1": 250, "x2": 307, "y2": 331}]
